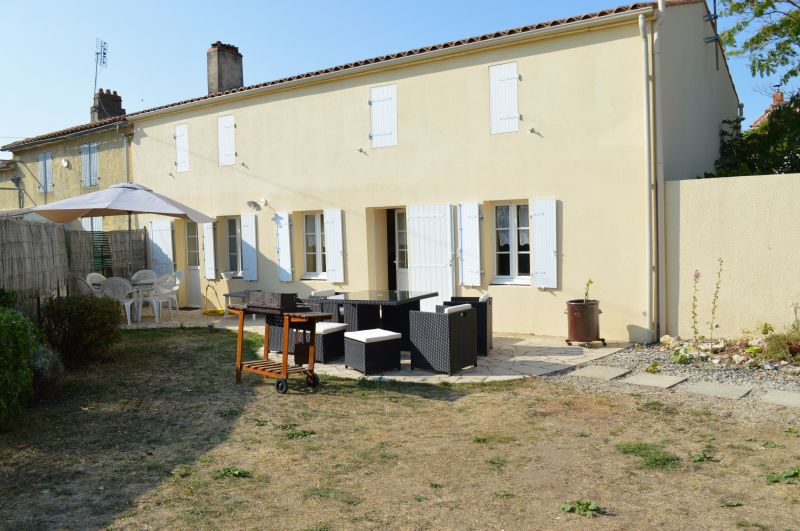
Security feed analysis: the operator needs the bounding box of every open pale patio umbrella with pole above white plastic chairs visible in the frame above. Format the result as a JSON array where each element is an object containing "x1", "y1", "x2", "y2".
[{"x1": 33, "y1": 183, "x2": 214, "y2": 276}]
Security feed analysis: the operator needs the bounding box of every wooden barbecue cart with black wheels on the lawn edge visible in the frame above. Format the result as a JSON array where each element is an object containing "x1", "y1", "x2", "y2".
[{"x1": 228, "y1": 291, "x2": 333, "y2": 394}]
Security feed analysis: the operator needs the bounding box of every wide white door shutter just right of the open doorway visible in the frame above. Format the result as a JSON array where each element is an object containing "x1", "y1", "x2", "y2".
[{"x1": 406, "y1": 205, "x2": 454, "y2": 311}]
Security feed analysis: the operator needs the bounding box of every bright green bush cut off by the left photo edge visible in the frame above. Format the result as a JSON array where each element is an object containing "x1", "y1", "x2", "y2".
[{"x1": 0, "y1": 308, "x2": 39, "y2": 422}]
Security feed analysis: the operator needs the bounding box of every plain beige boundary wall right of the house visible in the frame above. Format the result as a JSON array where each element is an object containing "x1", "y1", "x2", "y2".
[{"x1": 666, "y1": 174, "x2": 800, "y2": 337}]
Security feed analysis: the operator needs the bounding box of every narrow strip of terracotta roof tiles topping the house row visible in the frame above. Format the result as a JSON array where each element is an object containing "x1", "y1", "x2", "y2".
[{"x1": 0, "y1": 0, "x2": 664, "y2": 151}]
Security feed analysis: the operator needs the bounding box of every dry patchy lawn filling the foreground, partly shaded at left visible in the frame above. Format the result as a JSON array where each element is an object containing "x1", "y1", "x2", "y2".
[{"x1": 0, "y1": 329, "x2": 800, "y2": 529}]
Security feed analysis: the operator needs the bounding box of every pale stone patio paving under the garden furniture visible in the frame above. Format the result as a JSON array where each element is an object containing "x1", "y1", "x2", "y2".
[{"x1": 121, "y1": 309, "x2": 627, "y2": 384}]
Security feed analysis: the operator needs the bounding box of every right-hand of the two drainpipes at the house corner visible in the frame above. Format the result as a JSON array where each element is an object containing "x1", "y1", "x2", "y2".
[{"x1": 653, "y1": 0, "x2": 667, "y2": 335}]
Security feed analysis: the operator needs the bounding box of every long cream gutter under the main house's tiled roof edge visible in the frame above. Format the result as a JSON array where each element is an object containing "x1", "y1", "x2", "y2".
[{"x1": 128, "y1": 6, "x2": 654, "y2": 121}]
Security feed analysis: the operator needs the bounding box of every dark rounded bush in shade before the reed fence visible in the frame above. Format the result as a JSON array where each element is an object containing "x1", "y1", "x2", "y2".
[{"x1": 41, "y1": 295, "x2": 122, "y2": 368}]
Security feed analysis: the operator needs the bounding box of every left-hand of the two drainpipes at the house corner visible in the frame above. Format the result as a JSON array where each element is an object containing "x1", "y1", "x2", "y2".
[{"x1": 639, "y1": 15, "x2": 653, "y2": 339}]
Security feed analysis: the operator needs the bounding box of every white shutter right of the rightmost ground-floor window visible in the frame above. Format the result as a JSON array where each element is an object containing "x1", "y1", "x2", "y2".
[{"x1": 531, "y1": 199, "x2": 558, "y2": 288}]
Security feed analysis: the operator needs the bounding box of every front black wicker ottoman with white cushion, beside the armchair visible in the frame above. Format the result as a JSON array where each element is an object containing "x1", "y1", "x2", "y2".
[{"x1": 344, "y1": 328, "x2": 401, "y2": 374}]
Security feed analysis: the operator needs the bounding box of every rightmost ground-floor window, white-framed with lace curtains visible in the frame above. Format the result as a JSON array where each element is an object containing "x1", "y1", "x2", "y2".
[{"x1": 494, "y1": 202, "x2": 531, "y2": 284}]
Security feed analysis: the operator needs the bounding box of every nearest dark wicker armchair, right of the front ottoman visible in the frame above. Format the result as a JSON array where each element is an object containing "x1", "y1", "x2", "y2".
[{"x1": 410, "y1": 304, "x2": 478, "y2": 374}]
